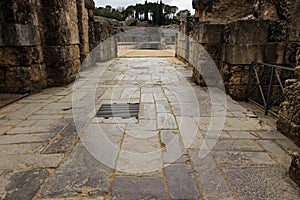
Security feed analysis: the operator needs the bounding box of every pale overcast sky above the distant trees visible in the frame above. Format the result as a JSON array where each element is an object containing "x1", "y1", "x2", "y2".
[{"x1": 94, "y1": 0, "x2": 194, "y2": 13}]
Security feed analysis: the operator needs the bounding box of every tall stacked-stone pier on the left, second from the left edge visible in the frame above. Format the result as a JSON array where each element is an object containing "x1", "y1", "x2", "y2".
[{"x1": 40, "y1": 0, "x2": 80, "y2": 86}]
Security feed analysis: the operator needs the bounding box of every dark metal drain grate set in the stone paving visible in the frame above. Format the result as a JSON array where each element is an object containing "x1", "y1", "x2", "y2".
[{"x1": 96, "y1": 103, "x2": 140, "y2": 119}]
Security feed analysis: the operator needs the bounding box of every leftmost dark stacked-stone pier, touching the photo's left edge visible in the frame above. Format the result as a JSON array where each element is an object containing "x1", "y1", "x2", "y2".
[{"x1": 0, "y1": 0, "x2": 47, "y2": 93}]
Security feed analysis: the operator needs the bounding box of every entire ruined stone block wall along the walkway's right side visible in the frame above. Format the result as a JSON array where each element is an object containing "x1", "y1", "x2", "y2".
[{"x1": 178, "y1": 0, "x2": 300, "y2": 100}]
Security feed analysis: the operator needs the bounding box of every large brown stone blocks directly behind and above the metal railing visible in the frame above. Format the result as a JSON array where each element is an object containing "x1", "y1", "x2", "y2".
[{"x1": 221, "y1": 19, "x2": 291, "y2": 100}]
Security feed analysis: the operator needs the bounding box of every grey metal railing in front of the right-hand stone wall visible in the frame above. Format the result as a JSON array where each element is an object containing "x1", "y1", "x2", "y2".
[{"x1": 246, "y1": 62, "x2": 295, "y2": 116}]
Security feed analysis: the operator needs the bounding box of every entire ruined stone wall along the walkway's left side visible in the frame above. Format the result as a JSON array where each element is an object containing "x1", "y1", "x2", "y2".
[{"x1": 0, "y1": 0, "x2": 116, "y2": 93}]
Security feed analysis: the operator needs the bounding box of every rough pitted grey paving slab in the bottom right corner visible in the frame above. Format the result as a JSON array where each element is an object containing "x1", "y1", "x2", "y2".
[{"x1": 223, "y1": 166, "x2": 300, "y2": 200}]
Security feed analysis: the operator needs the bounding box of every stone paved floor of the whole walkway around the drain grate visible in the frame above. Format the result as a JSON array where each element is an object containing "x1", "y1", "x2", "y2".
[{"x1": 0, "y1": 53, "x2": 300, "y2": 200}]
